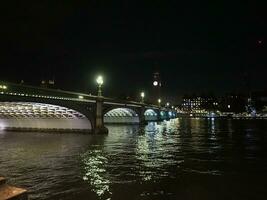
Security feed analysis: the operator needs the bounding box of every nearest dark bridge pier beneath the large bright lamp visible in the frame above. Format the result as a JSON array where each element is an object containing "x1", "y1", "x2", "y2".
[{"x1": 94, "y1": 97, "x2": 108, "y2": 134}]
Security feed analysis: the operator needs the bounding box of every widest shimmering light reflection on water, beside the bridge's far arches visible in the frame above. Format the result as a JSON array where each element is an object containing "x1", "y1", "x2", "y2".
[{"x1": 136, "y1": 121, "x2": 183, "y2": 182}]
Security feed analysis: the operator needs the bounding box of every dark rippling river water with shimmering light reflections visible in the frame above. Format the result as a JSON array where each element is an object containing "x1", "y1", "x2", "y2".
[{"x1": 0, "y1": 119, "x2": 267, "y2": 200}]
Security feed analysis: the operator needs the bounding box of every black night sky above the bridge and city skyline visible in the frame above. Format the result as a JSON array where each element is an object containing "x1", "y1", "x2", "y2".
[{"x1": 0, "y1": 0, "x2": 267, "y2": 101}]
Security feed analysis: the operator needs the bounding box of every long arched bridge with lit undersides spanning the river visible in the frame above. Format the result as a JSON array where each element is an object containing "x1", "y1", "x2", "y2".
[{"x1": 0, "y1": 82, "x2": 177, "y2": 133}]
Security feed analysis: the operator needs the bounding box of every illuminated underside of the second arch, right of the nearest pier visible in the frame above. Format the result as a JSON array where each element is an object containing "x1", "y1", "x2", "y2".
[{"x1": 104, "y1": 108, "x2": 139, "y2": 124}]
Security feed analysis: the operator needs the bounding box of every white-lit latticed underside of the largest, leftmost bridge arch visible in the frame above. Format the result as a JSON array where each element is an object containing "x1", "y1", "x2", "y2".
[{"x1": 0, "y1": 102, "x2": 92, "y2": 130}]
